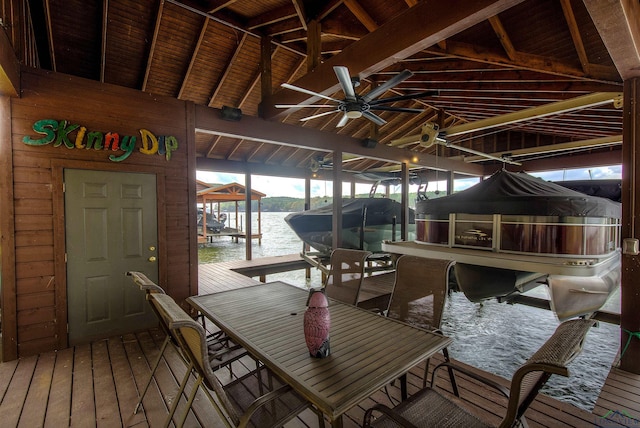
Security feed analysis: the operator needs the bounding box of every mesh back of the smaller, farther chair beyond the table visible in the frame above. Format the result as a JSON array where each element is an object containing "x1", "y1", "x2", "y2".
[{"x1": 324, "y1": 248, "x2": 371, "y2": 306}]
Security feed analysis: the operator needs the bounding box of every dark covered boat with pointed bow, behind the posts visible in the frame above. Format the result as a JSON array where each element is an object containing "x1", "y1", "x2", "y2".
[{"x1": 285, "y1": 198, "x2": 415, "y2": 254}]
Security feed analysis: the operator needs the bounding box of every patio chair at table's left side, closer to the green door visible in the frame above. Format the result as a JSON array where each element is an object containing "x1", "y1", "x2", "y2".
[{"x1": 127, "y1": 271, "x2": 247, "y2": 414}]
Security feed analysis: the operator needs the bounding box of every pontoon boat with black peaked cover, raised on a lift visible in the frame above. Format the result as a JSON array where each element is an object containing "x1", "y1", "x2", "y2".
[{"x1": 383, "y1": 171, "x2": 621, "y2": 320}]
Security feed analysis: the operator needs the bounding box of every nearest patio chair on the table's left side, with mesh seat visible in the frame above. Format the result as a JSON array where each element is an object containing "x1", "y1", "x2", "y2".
[{"x1": 151, "y1": 294, "x2": 316, "y2": 428}]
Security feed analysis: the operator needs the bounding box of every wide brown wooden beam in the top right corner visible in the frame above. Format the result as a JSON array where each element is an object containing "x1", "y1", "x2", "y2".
[{"x1": 583, "y1": 0, "x2": 640, "y2": 80}]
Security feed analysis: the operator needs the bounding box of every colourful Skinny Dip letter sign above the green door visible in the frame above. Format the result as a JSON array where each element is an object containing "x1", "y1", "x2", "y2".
[{"x1": 22, "y1": 119, "x2": 178, "y2": 162}]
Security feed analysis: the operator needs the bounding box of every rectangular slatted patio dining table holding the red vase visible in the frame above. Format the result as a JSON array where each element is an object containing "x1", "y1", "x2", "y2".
[{"x1": 187, "y1": 281, "x2": 452, "y2": 427}]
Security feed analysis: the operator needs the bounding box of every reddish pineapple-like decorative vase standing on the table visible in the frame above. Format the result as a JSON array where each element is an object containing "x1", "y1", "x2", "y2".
[{"x1": 304, "y1": 288, "x2": 331, "y2": 358}]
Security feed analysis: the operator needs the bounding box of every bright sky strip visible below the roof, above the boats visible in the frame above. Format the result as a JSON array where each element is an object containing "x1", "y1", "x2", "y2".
[{"x1": 196, "y1": 165, "x2": 622, "y2": 198}]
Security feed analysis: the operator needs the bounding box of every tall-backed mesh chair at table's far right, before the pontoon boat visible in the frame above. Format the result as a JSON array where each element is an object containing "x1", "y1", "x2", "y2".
[{"x1": 387, "y1": 255, "x2": 457, "y2": 400}]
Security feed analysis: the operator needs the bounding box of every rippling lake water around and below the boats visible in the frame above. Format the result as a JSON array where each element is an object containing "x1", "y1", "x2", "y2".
[{"x1": 199, "y1": 212, "x2": 620, "y2": 411}]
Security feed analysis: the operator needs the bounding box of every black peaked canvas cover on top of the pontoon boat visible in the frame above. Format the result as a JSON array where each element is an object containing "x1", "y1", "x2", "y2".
[{"x1": 416, "y1": 171, "x2": 622, "y2": 219}]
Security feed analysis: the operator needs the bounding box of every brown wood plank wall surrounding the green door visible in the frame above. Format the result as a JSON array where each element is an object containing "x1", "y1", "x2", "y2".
[{"x1": 2, "y1": 68, "x2": 197, "y2": 356}]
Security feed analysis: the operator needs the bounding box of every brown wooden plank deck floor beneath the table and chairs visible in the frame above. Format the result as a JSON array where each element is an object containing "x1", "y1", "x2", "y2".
[{"x1": 0, "y1": 256, "x2": 640, "y2": 428}]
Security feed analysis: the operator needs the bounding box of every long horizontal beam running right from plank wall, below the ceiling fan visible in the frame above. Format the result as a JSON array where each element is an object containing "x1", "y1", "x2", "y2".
[{"x1": 196, "y1": 105, "x2": 483, "y2": 175}]
